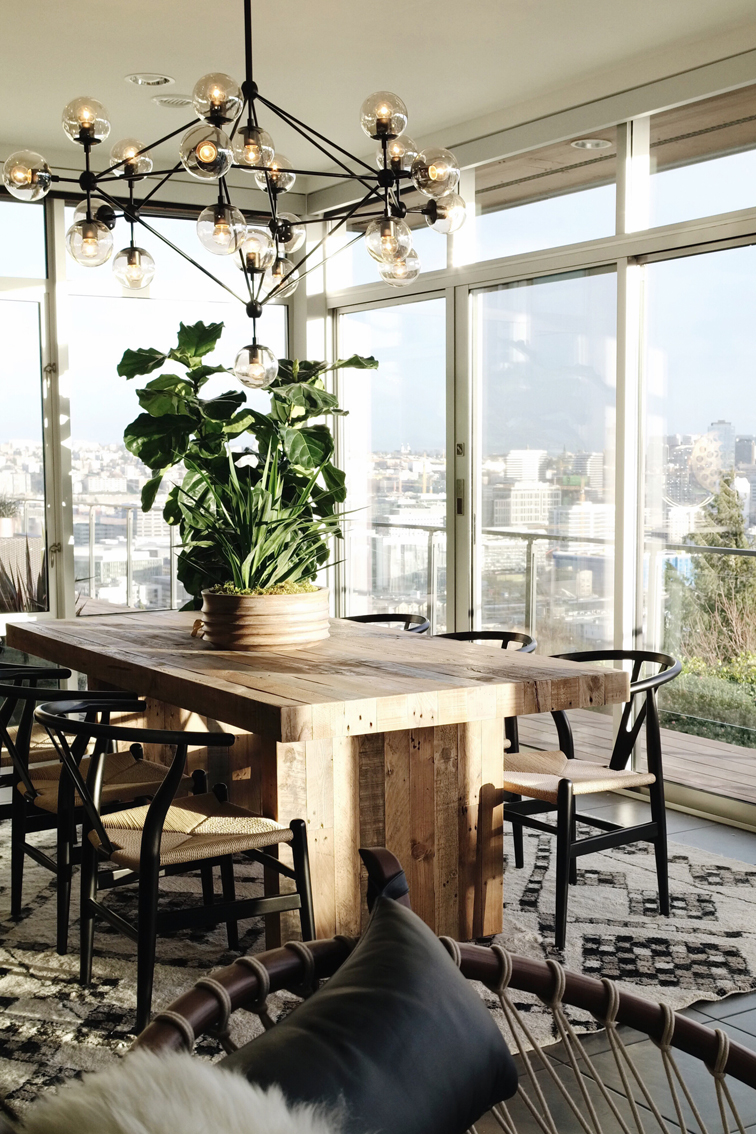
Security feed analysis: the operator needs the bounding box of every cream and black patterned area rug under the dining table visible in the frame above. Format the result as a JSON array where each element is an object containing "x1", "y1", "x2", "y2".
[{"x1": 0, "y1": 823, "x2": 756, "y2": 1109}]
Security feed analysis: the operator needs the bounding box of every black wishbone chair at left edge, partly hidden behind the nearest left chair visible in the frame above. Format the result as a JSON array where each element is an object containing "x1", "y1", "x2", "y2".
[{"x1": 0, "y1": 669, "x2": 192, "y2": 955}]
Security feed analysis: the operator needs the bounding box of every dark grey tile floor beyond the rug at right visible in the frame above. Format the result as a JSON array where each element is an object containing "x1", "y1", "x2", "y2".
[{"x1": 487, "y1": 793, "x2": 756, "y2": 1134}]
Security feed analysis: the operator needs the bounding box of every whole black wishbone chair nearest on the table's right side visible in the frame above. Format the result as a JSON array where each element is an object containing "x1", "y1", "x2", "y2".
[{"x1": 478, "y1": 650, "x2": 682, "y2": 949}]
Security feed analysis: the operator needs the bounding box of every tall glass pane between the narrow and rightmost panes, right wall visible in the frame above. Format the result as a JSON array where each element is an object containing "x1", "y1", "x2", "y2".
[{"x1": 473, "y1": 271, "x2": 617, "y2": 652}]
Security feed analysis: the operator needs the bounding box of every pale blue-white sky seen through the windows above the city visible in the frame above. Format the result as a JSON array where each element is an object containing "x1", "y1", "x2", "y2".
[{"x1": 0, "y1": 144, "x2": 756, "y2": 451}]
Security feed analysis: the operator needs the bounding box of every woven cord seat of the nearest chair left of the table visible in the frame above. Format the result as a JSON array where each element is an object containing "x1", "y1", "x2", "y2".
[{"x1": 90, "y1": 792, "x2": 292, "y2": 870}]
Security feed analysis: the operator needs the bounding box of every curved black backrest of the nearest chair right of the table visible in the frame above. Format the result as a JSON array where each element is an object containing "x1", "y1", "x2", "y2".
[{"x1": 552, "y1": 650, "x2": 682, "y2": 775}]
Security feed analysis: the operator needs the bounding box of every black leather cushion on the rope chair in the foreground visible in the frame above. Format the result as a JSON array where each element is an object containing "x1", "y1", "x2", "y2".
[{"x1": 222, "y1": 897, "x2": 517, "y2": 1134}]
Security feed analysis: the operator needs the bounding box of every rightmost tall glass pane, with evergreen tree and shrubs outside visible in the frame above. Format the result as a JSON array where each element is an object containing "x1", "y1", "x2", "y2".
[{"x1": 643, "y1": 246, "x2": 756, "y2": 801}]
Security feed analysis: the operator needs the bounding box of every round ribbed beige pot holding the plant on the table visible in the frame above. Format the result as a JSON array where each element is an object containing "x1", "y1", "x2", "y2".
[{"x1": 202, "y1": 586, "x2": 329, "y2": 650}]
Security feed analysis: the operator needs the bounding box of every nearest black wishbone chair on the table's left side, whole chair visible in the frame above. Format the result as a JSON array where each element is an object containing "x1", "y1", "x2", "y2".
[{"x1": 35, "y1": 700, "x2": 315, "y2": 1032}]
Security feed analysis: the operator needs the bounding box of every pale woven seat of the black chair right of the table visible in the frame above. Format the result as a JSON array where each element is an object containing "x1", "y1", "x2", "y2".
[{"x1": 501, "y1": 752, "x2": 656, "y2": 805}]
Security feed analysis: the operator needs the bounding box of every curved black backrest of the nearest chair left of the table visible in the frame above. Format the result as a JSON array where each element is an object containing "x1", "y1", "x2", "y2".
[{"x1": 34, "y1": 693, "x2": 236, "y2": 857}]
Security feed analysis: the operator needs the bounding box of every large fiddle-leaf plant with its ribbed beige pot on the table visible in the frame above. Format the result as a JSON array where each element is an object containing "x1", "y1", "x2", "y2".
[{"x1": 118, "y1": 323, "x2": 377, "y2": 650}]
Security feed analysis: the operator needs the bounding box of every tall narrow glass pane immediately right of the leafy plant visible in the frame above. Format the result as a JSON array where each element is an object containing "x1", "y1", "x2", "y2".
[{"x1": 339, "y1": 298, "x2": 447, "y2": 631}]
